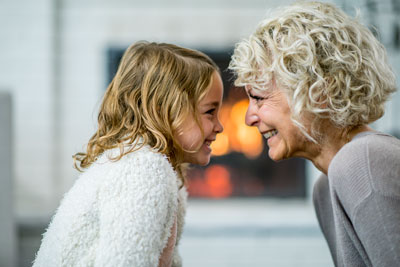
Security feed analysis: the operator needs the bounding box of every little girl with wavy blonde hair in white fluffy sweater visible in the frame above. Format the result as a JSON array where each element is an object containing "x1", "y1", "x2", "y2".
[{"x1": 34, "y1": 42, "x2": 223, "y2": 267}]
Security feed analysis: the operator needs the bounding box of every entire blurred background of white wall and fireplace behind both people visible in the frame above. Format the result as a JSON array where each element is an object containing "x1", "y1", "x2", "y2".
[{"x1": 0, "y1": 0, "x2": 400, "y2": 267}]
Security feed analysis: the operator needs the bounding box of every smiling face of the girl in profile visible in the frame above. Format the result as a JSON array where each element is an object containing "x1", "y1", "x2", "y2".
[{"x1": 176, "y1": 71, "x2": 223, "y2": 166}]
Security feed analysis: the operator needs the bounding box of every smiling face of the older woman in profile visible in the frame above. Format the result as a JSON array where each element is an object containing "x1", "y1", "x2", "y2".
[{"x1": 246, "y1": 82, "x2": 312, "y2": 161}]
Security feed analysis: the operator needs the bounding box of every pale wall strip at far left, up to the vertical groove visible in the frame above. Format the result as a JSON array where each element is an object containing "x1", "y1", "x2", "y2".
[{"x1": 0, "y1": 0, "x2": 52, "y2": 217}]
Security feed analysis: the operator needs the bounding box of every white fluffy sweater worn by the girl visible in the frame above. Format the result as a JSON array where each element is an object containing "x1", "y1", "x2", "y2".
[{"x1": 33, "y1": 146, "x2": 187, "y2": 267}]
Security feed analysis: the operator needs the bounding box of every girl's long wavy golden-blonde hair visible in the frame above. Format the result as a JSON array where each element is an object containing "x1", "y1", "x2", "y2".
[{"x1": 73, "y1": 41, "x2": 219, "y2": 183}]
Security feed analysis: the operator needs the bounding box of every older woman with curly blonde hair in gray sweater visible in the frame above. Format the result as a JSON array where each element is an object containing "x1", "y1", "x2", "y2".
[{"x1": 230, "y1": 2, "x2": 400, "y2": 267}]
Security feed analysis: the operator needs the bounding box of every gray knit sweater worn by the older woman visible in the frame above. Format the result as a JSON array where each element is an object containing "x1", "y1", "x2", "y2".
[{"x1": 313, "y1": 132, "x2": 400, "y2": 267}]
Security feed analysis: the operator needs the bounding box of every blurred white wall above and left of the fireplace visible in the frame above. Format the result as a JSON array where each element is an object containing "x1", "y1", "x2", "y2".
[{"x1": 0, "y1": 0, "x2": 400, "y2": 216}]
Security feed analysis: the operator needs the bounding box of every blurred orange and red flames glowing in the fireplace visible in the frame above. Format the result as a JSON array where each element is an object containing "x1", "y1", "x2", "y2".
[{"x1": 188, "y1": 99, "x2": 264, "y2": 198}]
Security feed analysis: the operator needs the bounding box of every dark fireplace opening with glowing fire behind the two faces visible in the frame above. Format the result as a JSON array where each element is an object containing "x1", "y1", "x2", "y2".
[{"x1": 107, "y1": 48, "x2": 306, "y2": 198}]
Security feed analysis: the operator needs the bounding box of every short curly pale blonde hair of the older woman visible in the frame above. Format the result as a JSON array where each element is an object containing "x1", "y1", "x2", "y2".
[{"x1": 229, "y1": 2, "x2": 396, "y2": 143}]
